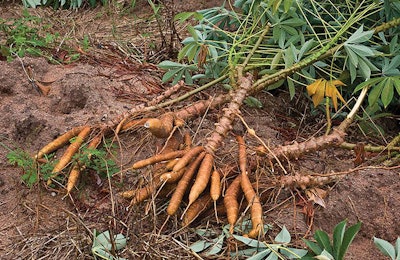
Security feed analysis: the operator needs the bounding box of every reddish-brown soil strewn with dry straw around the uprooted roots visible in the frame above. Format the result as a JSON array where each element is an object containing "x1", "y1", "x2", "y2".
[{"x1": 0, "y1": 1, "x2": 400, "y2": 259}]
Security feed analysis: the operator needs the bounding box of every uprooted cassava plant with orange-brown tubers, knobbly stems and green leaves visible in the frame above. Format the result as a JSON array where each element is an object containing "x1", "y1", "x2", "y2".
[{"x1": 11, "y1": 0, "x2": 400, "y2": 246}]
